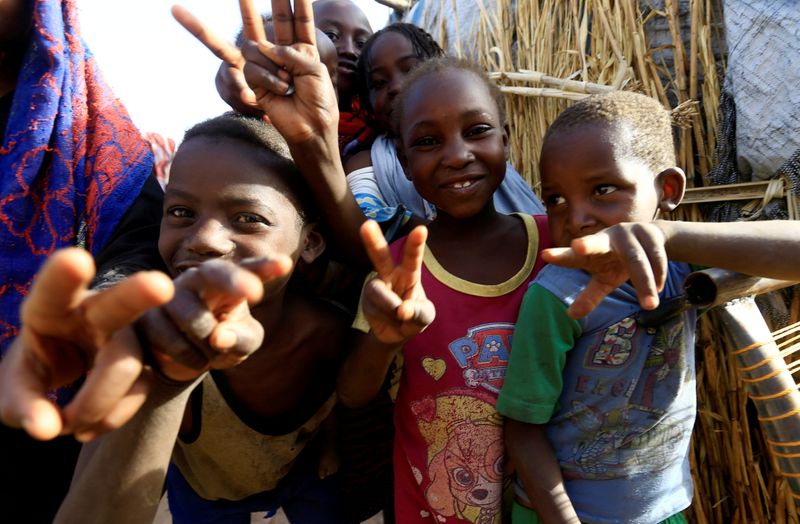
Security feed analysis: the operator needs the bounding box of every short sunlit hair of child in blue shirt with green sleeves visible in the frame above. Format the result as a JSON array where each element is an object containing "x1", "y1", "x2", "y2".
[{"x1": 542, "y1": 91, "x2": 676, "y2": 174}]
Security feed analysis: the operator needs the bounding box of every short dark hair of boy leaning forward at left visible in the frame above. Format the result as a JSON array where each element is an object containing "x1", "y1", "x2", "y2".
[{"x1": 183, "y1": 111, "x2": 319, "y2": 222}]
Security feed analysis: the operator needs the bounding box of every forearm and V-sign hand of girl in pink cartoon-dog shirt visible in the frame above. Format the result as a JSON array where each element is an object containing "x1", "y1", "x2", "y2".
[{"x1": 336, "y1": 221, "x2": 436, "y2": 407}]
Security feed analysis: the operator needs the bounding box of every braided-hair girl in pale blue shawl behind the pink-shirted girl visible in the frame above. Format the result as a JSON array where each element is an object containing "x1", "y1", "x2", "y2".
[{"x1": 345, "y1": 23, "x2": 544, "y2": 239}]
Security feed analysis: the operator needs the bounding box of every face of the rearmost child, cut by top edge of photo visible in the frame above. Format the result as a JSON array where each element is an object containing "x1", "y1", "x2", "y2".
[{"x1": 312, "y1": 0, "x2": 372, "y2": 105}]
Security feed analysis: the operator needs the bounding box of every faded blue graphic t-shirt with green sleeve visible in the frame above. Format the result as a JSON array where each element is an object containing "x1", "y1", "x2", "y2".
[{"x1": 498, "y1": 263, "x2": 696, "y2": 523}]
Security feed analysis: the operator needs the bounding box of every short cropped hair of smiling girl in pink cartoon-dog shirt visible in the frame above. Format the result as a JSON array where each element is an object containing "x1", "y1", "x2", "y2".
[{"x1": 392, "y1": 56, "x2": 506, "y2": 144}]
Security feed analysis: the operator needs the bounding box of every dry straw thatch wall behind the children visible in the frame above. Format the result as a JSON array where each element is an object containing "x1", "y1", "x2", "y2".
[{"x1": 410, "y1": 0, "x2": 798, "y2": 523}]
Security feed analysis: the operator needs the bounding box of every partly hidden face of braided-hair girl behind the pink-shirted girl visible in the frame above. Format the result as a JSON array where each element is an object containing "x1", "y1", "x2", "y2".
[{"x1": 366, "y1": 31, "x2": 420, "y2": 130}]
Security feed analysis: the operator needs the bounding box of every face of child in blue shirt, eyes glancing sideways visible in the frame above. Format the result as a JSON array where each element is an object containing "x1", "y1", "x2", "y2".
[{"x1": 540, "y1": 123, "x2": 664, "y2": 247}]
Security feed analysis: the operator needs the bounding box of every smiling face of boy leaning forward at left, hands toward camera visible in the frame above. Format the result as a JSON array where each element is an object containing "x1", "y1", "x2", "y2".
[{"x1": 158, "y1": 136, "x2": 311, "y2": 290}]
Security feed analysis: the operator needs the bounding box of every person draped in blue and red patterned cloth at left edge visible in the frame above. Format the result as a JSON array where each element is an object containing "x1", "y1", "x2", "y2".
[{"x1": 0, "y1": 0, "x2": 162, "y2": 522}]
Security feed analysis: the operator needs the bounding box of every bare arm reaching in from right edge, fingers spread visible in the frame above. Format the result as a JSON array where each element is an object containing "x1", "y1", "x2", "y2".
[{"x1": 542, "y1": 220, "x2": 800, "y2": 318}]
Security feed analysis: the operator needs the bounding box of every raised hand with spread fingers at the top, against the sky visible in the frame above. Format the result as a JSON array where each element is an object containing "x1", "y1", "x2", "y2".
[{"x1": 173, "y1": 0, "x2": 339, "y2": 144}]
